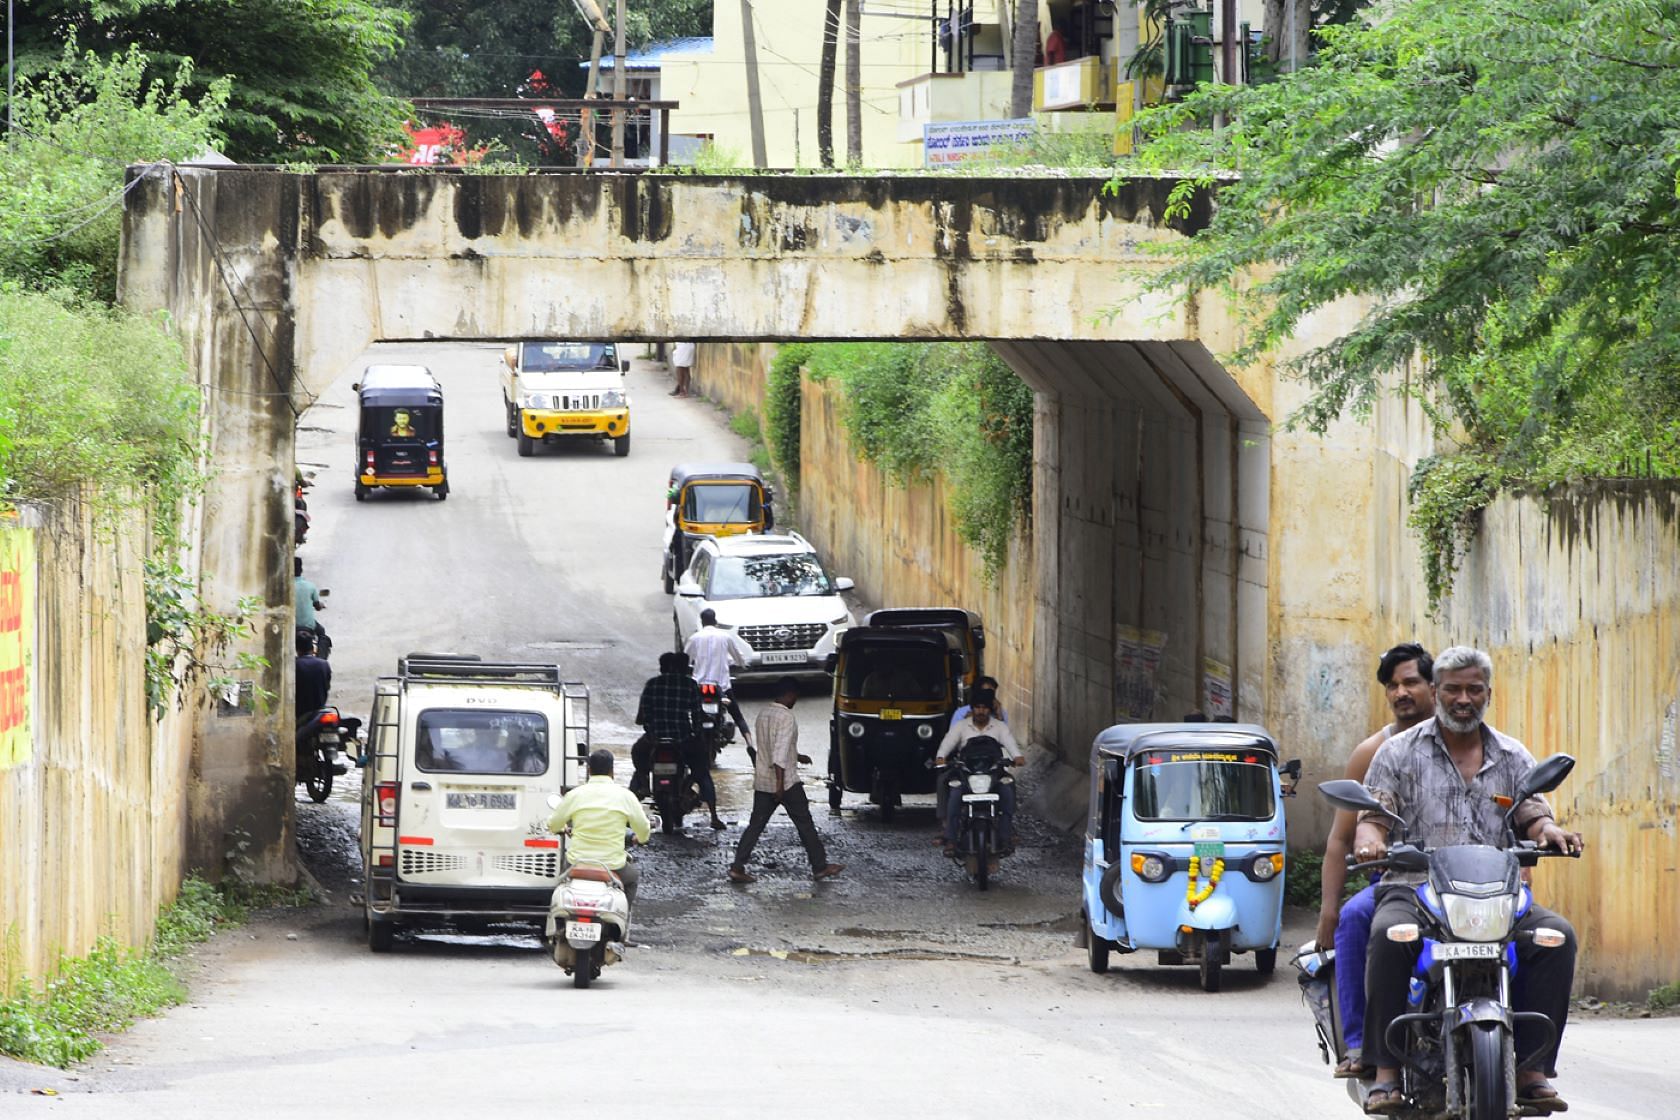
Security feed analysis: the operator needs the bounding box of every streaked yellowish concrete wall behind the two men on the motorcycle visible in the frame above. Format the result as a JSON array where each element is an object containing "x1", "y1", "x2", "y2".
[{"x1": 1381, "y1": 483, "x2": 1680, "y2": 999}]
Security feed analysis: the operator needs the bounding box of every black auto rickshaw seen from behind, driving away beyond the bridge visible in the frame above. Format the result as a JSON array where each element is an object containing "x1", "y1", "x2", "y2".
[{"x1": 351, "y1": 366, "x2": 449, "y2": 502}]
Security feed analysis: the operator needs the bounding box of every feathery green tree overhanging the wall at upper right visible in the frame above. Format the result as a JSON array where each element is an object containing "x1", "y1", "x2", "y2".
[{"x1": 1131, "y1": 0, "x2": 1680, "y2": 599}]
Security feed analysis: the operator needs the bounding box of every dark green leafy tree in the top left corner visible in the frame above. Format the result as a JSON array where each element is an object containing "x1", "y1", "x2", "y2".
[{"x1": 7, "y1": 0, "x2": 408, "y2": 163}]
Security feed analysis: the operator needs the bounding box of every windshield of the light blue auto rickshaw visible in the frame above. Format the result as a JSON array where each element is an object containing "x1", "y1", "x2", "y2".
[{"x1": 1132, "y1": 749, "x2": 1277, "y2": 821}]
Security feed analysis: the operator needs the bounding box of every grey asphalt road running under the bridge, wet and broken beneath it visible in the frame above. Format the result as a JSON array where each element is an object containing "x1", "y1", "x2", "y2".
[{"x1": 0, "y1": 346, "x2": 1680, "y2": 1120}]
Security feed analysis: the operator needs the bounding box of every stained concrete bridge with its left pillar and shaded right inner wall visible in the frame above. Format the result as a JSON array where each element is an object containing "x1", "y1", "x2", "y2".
[{"x1": 121, "y1": 168, "x2": 1280, "y2": 878}]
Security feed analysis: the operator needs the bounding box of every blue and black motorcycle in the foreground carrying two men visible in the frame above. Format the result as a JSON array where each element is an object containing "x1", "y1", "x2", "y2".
[{"x1": 1317, "y1": 754, "x2": 1579, "y2": 1120}]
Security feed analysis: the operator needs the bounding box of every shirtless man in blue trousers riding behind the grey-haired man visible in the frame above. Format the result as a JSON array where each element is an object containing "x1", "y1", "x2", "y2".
[{"x1": 1317, "y1": 641, "x2": 1435, "y2": 1078}]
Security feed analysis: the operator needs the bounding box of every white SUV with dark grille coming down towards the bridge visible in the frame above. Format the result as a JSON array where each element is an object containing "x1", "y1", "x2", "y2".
[{"x1": 672, "y1": 532, "x2": 852, "y2": 675}]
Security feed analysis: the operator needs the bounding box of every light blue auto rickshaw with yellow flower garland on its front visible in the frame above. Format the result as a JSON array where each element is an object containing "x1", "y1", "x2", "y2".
[{"x1": 1082, "y1": 724, "x2": 1300, "y2": 992}]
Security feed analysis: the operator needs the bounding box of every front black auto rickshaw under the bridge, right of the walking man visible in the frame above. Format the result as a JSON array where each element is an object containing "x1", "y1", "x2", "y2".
[{"x1": 828, "y1": 626, "x2": 968, "y2": 821}]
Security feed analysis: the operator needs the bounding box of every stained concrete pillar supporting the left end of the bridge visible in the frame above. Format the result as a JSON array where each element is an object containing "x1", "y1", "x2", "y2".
[{"x1": 119, "y1": 173, "x2": 299, "y2": 880}]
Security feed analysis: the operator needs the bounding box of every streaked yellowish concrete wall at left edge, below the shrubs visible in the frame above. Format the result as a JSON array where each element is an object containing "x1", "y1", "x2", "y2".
[{"x1": 0, "y1": 505, "x2": 190, "y2": 996}]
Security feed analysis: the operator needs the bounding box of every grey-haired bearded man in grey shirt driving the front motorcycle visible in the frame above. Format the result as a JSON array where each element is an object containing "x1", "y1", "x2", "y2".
[{"x1": 1354, "y1": 646, "x2": 1583, "y2": 1115}]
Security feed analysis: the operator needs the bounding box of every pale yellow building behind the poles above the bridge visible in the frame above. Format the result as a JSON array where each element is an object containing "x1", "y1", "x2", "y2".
[{"x1": 635, "y1": 0, "x2": 1262, "y2": 168}]
